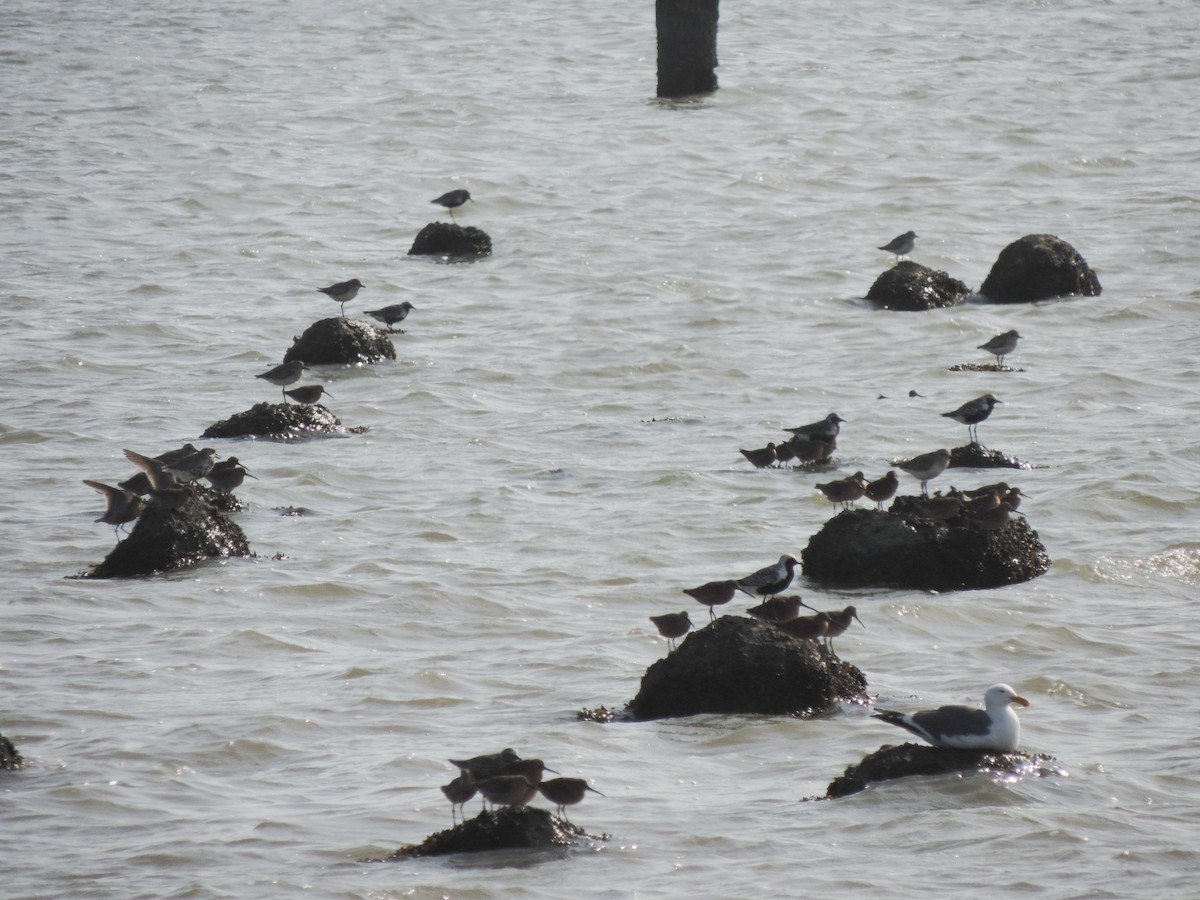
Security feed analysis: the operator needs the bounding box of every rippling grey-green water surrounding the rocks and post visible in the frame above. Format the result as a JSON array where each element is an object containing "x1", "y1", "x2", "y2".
[{"x1": 0, "y1": 0, "x2": 1200, "y2": 898}]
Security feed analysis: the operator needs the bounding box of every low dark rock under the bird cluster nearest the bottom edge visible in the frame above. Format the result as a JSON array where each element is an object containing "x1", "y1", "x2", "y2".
[{"x1": 367, "y1": 806, "x2": 583, "y2": 862}]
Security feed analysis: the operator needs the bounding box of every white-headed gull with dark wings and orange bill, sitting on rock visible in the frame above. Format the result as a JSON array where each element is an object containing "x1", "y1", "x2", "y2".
[{"x1": 872, "y1": 684, "x2": 1030, "y2": 754}]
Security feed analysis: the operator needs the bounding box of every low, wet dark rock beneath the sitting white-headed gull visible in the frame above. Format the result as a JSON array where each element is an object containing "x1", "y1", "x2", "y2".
[{"x1": 826, "y1": 744, "x2": 1066, "y2": 799}]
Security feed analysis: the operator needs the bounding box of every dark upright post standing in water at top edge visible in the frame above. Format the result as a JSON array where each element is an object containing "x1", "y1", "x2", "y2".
[{"x1": 655, "y1": 0, "x2": 718, "y2": 97}]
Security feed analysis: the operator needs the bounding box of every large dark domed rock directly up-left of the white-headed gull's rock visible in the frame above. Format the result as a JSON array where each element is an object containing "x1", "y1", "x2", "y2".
[{"x1": 626, "y1": 616, "x2": 866, "y2": 720}]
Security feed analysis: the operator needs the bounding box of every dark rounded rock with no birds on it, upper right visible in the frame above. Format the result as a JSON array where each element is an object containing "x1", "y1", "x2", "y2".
[{"x1": 979, "y1": 234, "x2": 1100, "y2": 304}]
